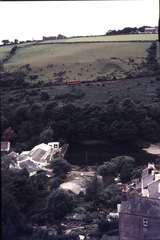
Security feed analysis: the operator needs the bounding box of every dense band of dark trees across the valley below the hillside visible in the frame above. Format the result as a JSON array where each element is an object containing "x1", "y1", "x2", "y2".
[{"x1": 1, "y1": 99, "x2": 160, "y2": 152}]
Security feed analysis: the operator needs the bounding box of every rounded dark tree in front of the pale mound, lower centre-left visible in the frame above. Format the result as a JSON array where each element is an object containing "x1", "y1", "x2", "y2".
[{"x1": 46, "y1": 189, "x2": 75, "y2": 234}]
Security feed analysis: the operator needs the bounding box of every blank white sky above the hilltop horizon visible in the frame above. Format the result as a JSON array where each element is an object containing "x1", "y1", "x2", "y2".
[{"x1": 0, "y1": 0, "x2": 159, "y2": 41}]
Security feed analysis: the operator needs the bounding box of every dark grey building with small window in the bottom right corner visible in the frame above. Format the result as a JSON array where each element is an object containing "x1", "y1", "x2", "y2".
[{"x1": 119, "y1": 195, "x2": 160, "y2": 240}]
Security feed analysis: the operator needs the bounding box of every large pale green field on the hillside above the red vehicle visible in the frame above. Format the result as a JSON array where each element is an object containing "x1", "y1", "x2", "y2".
[{"x1": 5, "y1": 42, "x2": 151, "y2": 81}]
